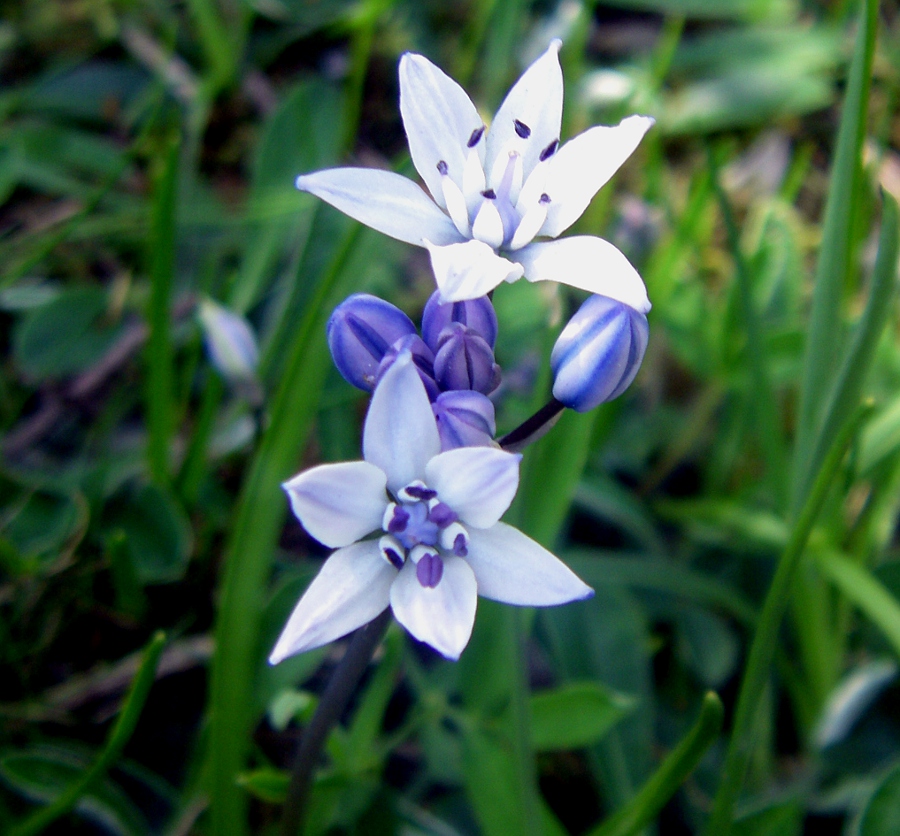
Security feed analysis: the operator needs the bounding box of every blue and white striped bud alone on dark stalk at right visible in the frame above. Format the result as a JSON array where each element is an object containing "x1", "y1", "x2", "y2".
[{"x1": 550, "y1": 296, "x2": 650, "y2": 412}]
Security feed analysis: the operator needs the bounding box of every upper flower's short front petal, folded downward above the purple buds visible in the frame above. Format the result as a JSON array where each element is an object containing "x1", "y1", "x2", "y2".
[{"x1": 425, "y1": 241, "x2": 523, "y2": 302}]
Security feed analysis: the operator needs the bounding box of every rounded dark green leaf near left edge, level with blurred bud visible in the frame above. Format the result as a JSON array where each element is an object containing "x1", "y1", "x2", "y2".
[{"x1": 13, "y1": 287, "x2": 121, "y2": 380}]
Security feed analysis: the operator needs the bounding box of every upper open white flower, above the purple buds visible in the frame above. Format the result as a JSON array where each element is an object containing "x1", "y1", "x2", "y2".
[{"x1": 297, "y1": 40, "x2": 653, "y2": 306}]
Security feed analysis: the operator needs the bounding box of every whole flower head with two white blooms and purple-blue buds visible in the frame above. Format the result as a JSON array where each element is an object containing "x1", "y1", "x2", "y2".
[{"x1": 270, "y1": 41, "x2": 653, "y2": 664}]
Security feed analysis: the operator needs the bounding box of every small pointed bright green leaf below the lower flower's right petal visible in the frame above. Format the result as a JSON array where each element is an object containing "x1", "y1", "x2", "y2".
[{"x1": 531, "y1": 682, "x2": 635, "y2": 752}]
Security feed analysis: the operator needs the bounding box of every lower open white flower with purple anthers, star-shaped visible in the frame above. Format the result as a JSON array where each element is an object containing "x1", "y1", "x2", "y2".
[{"x1": 269, "y1": 352, "x2": 593, "y2": 664}]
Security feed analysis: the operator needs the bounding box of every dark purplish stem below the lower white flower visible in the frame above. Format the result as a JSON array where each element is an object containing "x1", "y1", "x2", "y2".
[{"x1": 281, "y1": 607, "x2": 391, "y2": 836}]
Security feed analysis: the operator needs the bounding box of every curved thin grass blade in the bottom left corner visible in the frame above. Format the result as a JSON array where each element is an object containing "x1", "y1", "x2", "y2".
[{"x1": 8, "y1": 632, "x2": 166, "y2": 836}]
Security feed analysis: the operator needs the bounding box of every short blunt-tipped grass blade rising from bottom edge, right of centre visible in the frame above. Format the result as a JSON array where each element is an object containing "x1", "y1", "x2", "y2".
[{"x1": 590, "y1": 691, "x2": 724, "y2": 836}]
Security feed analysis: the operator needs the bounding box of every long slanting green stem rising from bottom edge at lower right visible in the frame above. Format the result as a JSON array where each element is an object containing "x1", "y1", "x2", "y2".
[{"x1": 705, "y1": 409, "x2": 867, "y2": 836}]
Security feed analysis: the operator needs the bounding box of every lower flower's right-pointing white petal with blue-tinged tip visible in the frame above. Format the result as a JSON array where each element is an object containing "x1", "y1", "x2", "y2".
[{"x1": 466, "y1": 523, "x2": 594, "y2": 607}]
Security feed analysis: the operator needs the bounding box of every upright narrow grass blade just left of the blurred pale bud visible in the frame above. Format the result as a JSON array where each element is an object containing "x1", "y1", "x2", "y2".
[{"x1": 146, "y1": 139, "x2": 180, "y2": 485}]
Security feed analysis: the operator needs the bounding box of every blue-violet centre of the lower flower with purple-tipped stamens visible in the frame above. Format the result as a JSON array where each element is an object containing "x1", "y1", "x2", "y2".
[{"x1": 379, "y1": 481, "x2": 469, "y2": 589}]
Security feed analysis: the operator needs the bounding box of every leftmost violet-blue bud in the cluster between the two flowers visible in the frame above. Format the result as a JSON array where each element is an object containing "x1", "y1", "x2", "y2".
[{"x1": 325, "y1": 293, "x2": 416, "y2": 392}]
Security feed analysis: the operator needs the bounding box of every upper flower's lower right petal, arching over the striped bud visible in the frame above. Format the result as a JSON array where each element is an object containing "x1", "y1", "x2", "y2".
[{"x1": 516, "y1": 235, "x2": 650, "y2": 314}]
